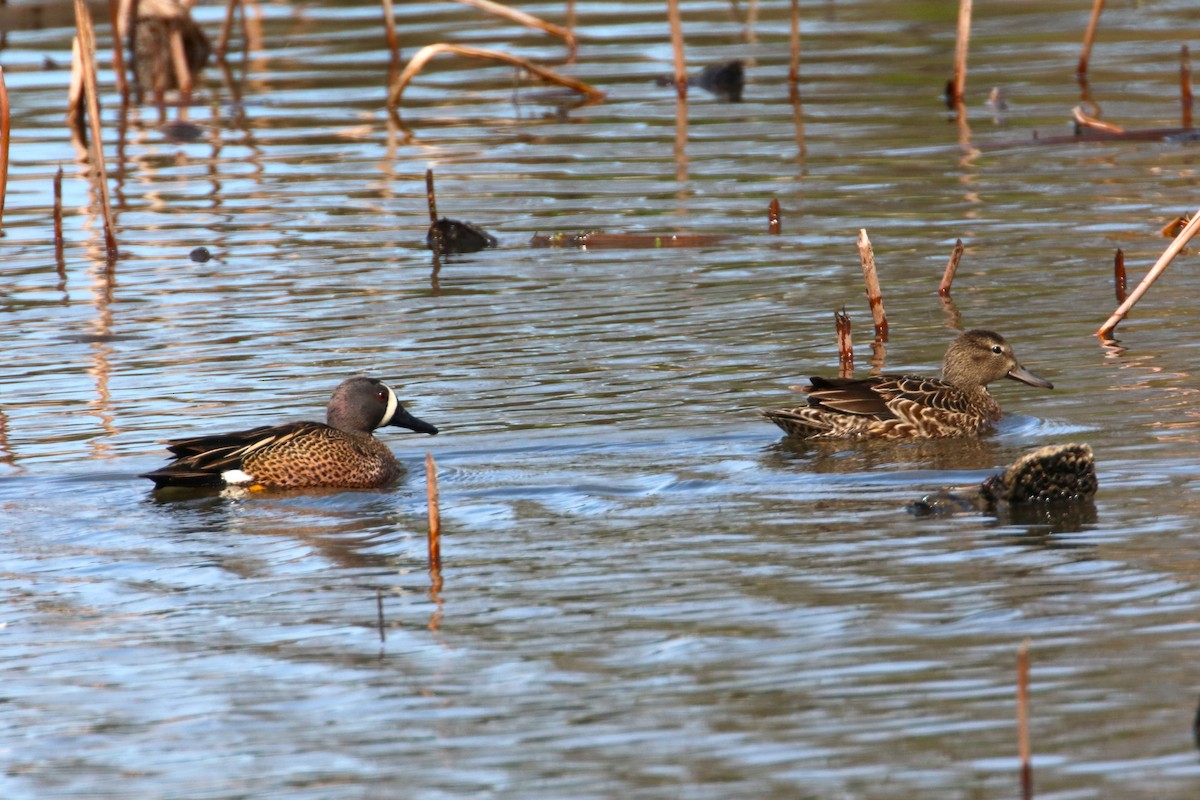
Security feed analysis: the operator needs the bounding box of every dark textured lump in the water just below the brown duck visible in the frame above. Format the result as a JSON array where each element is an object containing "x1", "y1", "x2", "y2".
[{"x1": 908, "y1": 444, "x2": 1098, "y2": 517}]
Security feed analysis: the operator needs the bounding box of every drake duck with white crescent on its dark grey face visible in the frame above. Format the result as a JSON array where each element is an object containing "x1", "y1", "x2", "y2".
[{"x1": 142, "y1": 378, "x2": 438, "y2": 488}]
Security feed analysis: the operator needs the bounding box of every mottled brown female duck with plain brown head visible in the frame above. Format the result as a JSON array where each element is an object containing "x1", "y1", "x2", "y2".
[{"x1": 762, "y1": 330, "x2": 1054, "y2": 439}]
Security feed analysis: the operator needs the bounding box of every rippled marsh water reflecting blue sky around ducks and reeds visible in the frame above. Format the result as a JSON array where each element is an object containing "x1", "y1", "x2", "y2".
[{"x1": 0, "y1": 0, "x2": 1200, "y2": 799}]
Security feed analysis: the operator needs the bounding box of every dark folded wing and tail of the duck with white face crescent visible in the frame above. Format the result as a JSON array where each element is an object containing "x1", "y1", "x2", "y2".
[{"x1": 140, "y1": 422, "x2": 329, "y2": 488}]
